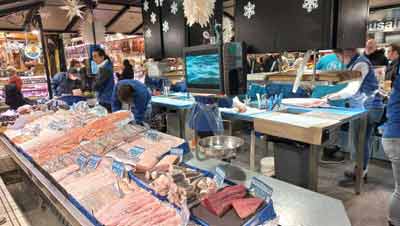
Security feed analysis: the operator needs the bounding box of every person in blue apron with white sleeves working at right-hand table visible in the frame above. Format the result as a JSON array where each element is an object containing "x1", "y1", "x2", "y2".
[{"x1": 327, "y1": 49, "x2": 384, "y2": 180}]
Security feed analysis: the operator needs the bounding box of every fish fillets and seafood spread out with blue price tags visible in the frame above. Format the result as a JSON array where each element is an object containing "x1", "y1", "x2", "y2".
[{"x1": 0, "y1": 103, "x2": 274, "y2": 226}]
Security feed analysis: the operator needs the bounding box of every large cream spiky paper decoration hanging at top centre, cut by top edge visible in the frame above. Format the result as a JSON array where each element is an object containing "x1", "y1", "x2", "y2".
[{"x1": 183, "y1": 0, "x2": 216, "y2": 27}]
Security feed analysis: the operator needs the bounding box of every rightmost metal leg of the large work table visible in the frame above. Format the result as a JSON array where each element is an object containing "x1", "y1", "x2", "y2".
[{"x1": 354, "y1": 114, "x2": 367, "y2": 195}]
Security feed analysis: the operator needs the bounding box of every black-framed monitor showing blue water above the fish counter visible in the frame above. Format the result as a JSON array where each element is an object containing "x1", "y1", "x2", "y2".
[{"x1": 184, "y1": 45, "x2": 223, "y2": 94}]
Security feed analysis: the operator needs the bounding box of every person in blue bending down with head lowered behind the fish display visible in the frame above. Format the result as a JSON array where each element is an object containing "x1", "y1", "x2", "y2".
[{"x1": 111, "y1": 79, "x2": 151, "y2": 124}]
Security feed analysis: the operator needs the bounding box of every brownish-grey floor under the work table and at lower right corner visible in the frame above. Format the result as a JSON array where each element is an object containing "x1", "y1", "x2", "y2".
[{"x1": 233, "y1": 144, "x2": 394, "y2": 226}]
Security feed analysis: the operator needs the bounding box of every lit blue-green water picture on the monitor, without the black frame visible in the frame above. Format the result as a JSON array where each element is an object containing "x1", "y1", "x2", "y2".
[{"x1": 186, "y1": 54, "x2": 221, "y2": 87}]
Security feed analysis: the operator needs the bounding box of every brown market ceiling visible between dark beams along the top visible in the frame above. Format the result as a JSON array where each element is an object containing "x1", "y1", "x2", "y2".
[{"x1": 0, "y1": 0, "x2": 400, "y2": 34}]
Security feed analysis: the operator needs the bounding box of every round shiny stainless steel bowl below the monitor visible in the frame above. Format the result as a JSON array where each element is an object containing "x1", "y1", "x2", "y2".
[{"x1": 198, "y1": 136, "x2": 244, "y2": 158}]
